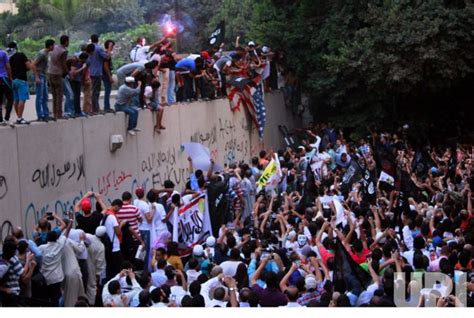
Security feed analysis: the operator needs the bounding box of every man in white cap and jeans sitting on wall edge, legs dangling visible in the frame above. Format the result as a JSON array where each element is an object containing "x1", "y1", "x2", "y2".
[{"x1": 115, "y1": 76, "x2": 141, "y2": 136}]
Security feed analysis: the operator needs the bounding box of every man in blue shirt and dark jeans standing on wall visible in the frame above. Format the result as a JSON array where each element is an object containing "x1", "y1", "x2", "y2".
[{"x1": 89, "y1": 34, "x2": 113, "y2": 113}]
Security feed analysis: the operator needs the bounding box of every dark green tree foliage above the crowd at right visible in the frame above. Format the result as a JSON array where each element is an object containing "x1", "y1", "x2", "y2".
[{"x1": 251, "y1": 0, "x2": 474, "y2": 134}]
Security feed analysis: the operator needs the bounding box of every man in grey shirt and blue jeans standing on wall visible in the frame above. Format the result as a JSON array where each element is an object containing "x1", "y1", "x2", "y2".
[{"x1": 33, "y1": 39, "x2": 54, "y2": 121}]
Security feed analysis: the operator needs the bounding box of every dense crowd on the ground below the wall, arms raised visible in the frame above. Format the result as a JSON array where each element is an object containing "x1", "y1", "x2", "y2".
[{"x1": 0, "y1": 124, "x2": 474, "y2": 307}]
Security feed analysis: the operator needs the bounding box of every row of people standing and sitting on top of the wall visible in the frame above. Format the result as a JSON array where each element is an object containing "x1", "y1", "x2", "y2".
[{"x1": 0, "y1": 34, "x2": 278, "y2": 135}]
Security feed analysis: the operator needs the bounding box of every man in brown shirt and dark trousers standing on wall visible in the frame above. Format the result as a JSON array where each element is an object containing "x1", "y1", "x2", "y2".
[{"x1": 48, "y1": 35, "x2": 69, "y2": 119}]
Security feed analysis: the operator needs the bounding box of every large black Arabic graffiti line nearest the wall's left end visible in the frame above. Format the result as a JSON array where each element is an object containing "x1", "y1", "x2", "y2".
[{"x1": 31, "y1": 155, "x2": 85, "y2": 189}]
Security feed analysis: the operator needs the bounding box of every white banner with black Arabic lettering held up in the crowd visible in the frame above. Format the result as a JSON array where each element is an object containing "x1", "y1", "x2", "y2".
[{"x1": 173, "y1": 194, "x2": 212, "y2": 255}]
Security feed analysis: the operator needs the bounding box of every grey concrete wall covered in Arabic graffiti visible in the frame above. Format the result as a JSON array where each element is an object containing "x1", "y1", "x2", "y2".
[{"x1": 0, "y1": 93, "x2": 296, "y2": 238}]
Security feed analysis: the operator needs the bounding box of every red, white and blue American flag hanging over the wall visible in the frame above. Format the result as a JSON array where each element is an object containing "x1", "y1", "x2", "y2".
[{"x1": 227, "y1": 76, "x2": 266, "y2": 138}]
